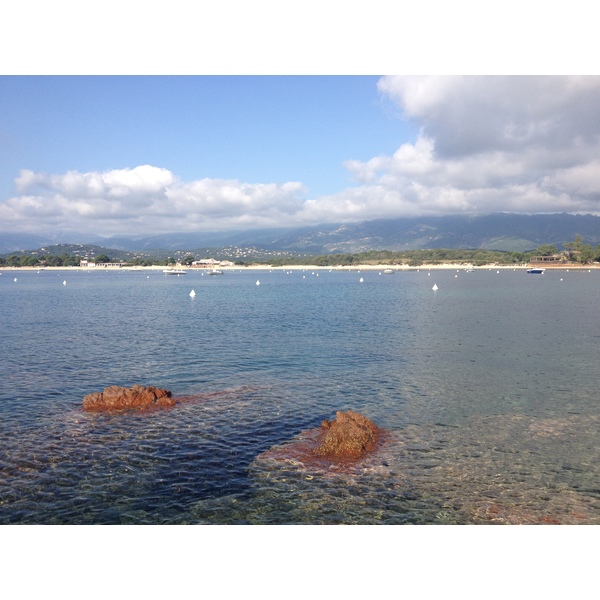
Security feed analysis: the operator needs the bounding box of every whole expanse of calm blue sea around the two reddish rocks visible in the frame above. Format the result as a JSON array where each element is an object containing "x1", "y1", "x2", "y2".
[{"x1": 0, "y1": 270, "x2": 600, "y2": 524}]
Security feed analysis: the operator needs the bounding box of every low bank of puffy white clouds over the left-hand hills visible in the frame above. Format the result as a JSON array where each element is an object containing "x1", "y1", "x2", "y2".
[{"x1": 0, "y1": 165, "x2": 303, "y2": 235}]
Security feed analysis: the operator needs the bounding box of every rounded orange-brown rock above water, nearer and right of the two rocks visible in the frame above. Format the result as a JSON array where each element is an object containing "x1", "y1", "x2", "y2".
[{"x1": 312, "y1": 410, "x2": 381, "y2": 458}]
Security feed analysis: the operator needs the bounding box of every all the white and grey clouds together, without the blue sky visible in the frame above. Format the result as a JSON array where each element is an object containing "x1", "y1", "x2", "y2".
[{"x1": 0, "y1": 76, "x2": 600, "y2": 235}]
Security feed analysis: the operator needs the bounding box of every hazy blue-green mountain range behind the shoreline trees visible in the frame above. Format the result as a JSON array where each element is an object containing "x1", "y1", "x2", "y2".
[{"x1": 0, "y1": 213, "x2": 600, "y2": 255}]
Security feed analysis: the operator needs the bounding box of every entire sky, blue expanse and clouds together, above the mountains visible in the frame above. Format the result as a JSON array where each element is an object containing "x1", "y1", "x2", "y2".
[{"x1": 0, "y1": 75, "x2": 600, "y2": 237}]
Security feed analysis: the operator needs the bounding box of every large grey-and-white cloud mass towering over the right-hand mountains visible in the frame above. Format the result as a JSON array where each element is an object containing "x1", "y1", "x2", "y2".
[{"x1": 313, "y1": 76, "x2": 600, "y2": 218}]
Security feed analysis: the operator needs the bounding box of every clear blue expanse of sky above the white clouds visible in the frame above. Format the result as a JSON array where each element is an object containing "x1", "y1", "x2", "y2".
[{"x1": 0, "y1": 76, "x2": 417, "y2": 199}]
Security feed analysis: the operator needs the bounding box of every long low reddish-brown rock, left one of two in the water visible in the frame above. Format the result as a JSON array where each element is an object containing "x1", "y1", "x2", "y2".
[{"x1": 83, "y1": 385, "x2": 176, "y2": 411}]
